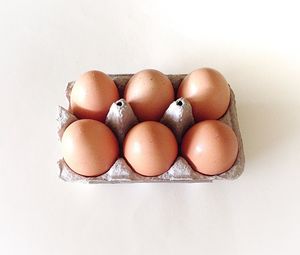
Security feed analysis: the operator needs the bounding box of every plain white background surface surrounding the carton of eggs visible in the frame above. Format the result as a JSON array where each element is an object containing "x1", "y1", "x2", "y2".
[{"x1": 0, "y1": 0, "x2": 300, "y2": 255}]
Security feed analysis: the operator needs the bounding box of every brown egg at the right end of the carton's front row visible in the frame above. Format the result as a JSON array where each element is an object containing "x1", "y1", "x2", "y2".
[{"x1": 181, "y1": 120, "x2": 238, "y2": 175}]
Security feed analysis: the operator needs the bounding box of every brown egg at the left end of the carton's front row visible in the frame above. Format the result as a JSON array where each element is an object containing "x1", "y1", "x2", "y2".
[{"x1": 62, "y1": 119, "x2": 119, "y2": 176}]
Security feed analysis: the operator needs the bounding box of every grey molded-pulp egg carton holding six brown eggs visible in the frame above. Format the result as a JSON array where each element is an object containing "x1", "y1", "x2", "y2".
[{"x1": 57, "y1": 74, "x2": 245, "y2": 183}]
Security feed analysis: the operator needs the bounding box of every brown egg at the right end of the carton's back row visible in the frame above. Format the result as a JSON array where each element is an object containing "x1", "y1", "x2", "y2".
[{"x1": 177, "y1": 68, "x2": 230, "y2": 121}]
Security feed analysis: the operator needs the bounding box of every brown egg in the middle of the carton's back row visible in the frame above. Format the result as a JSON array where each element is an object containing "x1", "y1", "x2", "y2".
[{"x1": 124, "y1": 69, "x2": 174, "y2": 121}]
